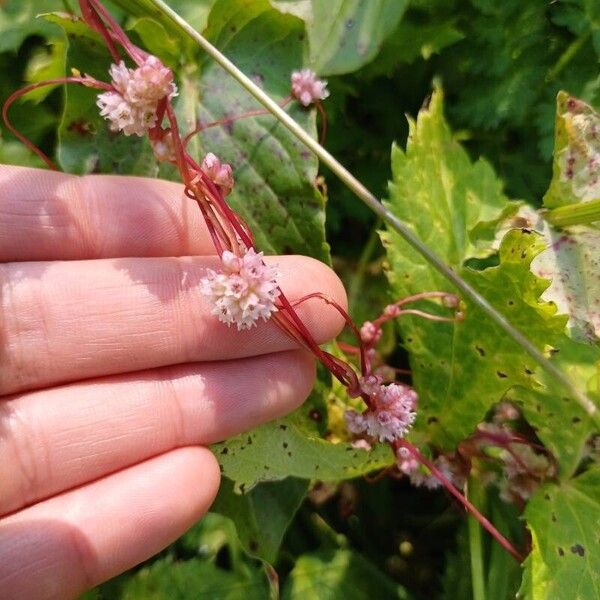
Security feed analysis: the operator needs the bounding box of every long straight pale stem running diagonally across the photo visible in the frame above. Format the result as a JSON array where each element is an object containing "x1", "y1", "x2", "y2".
[{"x1": 147, "y1": 0, "x2": 600, "y2": 427}]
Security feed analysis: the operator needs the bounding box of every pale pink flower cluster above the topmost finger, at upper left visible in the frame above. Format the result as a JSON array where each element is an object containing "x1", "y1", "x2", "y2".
[{"x1": 97, "y1": 56, "x2": 177, "y2": 136}]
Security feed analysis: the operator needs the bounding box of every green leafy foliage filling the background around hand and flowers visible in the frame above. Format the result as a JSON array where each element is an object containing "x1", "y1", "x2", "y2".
[{"x1": 0, "y1": 0, "x2": 600, "y2": 600}]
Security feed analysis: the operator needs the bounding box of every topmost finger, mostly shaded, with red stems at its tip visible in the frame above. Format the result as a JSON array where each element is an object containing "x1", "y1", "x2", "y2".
[{"x1": 0, "y1": 165, "x2": 215, "y2": 262}]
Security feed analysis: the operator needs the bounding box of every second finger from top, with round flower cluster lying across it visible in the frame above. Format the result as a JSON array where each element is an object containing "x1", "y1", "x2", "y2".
[{"x1": 0, "y1": 256, "x2": 345, "y2": 394}]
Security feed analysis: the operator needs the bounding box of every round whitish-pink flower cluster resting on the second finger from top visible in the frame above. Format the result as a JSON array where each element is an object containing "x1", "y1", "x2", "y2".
[{"x1": 200, "y1": 248, "x2": 280, "y2": 330}]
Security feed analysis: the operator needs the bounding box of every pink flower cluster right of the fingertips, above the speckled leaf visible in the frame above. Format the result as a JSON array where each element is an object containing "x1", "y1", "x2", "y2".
[{"x1": 344, "y1": 375, "x2": 417, "y2": 442}]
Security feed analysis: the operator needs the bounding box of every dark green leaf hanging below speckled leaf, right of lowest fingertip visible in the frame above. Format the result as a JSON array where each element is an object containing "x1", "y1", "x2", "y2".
[{"x1": 211, "y1": 478, "x2": 308, "y2": 563}]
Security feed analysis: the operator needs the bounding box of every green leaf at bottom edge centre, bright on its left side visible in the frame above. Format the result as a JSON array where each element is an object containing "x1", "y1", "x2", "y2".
[{"x1": 282, "y1": 550, "x2": 409, "y2": 600}]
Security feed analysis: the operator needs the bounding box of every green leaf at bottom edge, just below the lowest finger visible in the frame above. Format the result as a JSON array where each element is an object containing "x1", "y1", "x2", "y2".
[{"x1": 119, "y1": 558, "x2": 269, "y2": 600}]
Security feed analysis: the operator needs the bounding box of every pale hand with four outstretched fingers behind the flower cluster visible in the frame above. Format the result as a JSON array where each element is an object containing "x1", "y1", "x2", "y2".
[{"x1": 0, "y1": 166, "x2": 346, "y2": 600}]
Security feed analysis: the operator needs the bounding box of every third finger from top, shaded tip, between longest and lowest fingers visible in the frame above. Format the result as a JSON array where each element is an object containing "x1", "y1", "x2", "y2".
[{"x1": 0, "y1": 351, "x2": 315, "y2": 514}]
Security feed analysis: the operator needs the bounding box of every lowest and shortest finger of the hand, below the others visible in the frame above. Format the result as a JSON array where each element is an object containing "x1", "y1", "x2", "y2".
[{"x1": 0, "y1": 448, "x2": 219, "y2": 600}]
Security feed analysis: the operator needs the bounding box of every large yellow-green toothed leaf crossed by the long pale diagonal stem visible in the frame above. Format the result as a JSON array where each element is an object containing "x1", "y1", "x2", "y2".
[{"x1": 382, "y1": 91, "x2": 565, "y2": 448}]
